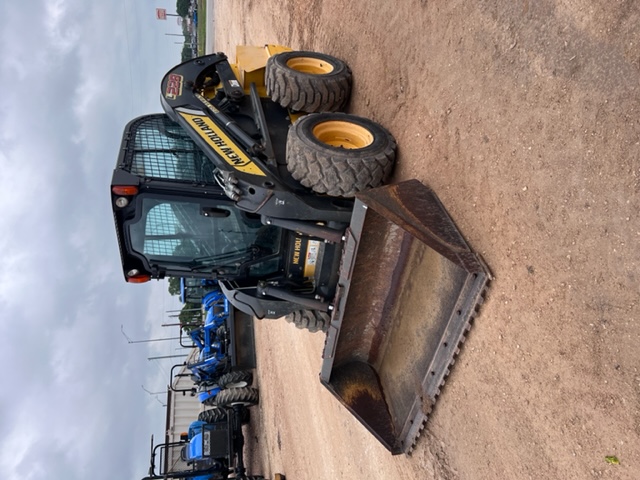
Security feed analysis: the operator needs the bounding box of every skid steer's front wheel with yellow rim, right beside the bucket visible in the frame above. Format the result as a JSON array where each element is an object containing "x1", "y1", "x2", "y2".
[{"x1": 287, "y1": 113, "x2": 396, "y2": 197}]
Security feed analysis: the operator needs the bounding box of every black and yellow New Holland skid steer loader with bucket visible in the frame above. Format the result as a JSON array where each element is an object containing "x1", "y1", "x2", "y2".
[{"x1": 111, "y1": 45, "x2": 490, "y2": 453}]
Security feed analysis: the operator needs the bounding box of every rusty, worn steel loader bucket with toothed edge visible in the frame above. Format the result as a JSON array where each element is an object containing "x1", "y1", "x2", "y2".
[{"x1": 320, "y1": 180, "x2": 490, "y2": 454}]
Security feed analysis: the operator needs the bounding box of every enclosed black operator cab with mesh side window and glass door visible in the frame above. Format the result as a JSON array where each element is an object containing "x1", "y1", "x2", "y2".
[{"x1": 112, "y1": 115, "x2": 283, "y2": 281}]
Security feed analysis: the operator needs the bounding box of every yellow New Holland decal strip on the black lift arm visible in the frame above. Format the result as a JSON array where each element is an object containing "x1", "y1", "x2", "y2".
[{"x1": 179, "y1": 112, "x2": 265, "y2": 177}]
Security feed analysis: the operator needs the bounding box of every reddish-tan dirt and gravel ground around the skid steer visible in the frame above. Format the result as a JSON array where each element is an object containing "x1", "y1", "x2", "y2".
[{"x1": 212, "y1": 0, "x2": 640, "y2": 479}]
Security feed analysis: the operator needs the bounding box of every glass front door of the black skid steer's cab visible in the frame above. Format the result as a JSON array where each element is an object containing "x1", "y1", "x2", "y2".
[{"x1": 124, "y1": 194, "x2": 281, "y2": 278}]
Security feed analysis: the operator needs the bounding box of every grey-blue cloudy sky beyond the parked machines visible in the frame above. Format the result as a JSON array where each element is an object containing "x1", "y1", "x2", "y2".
[{"x1": 0, "y1": 0, "x2": 194, "y2": 480}]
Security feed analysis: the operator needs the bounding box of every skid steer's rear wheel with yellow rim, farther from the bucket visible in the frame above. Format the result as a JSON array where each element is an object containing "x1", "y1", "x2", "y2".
[{"x1": 265, "y1": 52, "x2": 351, "y2": 113}]
